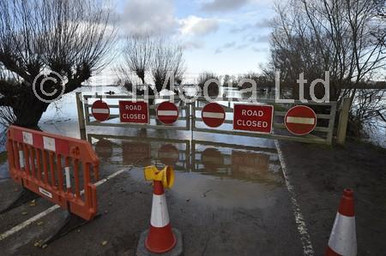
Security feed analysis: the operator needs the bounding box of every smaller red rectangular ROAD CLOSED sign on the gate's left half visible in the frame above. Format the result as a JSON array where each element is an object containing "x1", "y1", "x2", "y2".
[{"x1": 119, "y1": 100, "x2": 149, "y2": 124}]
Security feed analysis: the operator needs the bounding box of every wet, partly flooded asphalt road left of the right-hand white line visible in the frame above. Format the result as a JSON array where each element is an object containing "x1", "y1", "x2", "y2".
[{"x1": 0, "y1": 124, "x2": 303, "y2": 255}]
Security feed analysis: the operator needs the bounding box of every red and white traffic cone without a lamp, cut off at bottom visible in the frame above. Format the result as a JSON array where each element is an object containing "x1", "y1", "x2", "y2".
[{"x1": 325, "y1": 189, "x2": 357, "y2": 256}]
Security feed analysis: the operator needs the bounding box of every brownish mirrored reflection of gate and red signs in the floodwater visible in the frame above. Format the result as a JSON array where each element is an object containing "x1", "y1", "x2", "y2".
[{"x1": 88, "y1": 134, "x2": 282, "y2": 186}]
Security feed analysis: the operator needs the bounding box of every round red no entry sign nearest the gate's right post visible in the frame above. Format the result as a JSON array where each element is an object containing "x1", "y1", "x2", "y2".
[{"x1": 284, "y1": 105, "x2": 318, "y2": 135}]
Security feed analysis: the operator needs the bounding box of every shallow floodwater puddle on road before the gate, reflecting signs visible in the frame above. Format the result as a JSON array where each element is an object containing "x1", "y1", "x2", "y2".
[{"x1": 88, "y1": 134, "x2": 285, "y2": 210}]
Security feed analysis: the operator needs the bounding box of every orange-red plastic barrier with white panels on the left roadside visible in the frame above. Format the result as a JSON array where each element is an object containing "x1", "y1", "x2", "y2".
[{"x1": 7, "y1": 126, "x2": 99, "y2": 220}]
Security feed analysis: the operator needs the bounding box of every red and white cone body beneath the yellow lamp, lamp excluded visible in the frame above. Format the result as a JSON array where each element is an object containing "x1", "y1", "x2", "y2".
[{"x1": 145, "y1": 180, "x2": 177, "y2": 253}]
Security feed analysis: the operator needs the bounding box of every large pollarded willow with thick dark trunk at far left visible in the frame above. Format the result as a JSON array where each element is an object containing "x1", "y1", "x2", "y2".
[{"x1": 0, "y1": 0, "x2": 115, "y2": 128}]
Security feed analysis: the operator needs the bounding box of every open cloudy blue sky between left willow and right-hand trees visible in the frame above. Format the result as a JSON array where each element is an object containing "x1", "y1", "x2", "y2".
[{"x1": 92, "y1": 0, "x2": 275, "y2": 85}]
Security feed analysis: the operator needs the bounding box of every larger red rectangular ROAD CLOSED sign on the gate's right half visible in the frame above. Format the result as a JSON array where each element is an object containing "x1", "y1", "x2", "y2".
[{"x1": 233, "y1": 104, "x2": 273, "y2": 133}]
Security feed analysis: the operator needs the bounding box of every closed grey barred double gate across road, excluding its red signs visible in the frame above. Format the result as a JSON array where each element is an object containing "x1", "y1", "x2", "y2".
[{"x1": 76, "y1": 93, "x2": 336, "y2": 145}]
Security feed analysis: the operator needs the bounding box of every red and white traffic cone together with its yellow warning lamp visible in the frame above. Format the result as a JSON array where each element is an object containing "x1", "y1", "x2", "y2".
[{"x1": 145, "y1": 166, "x2": 177, "y2": 253}]
